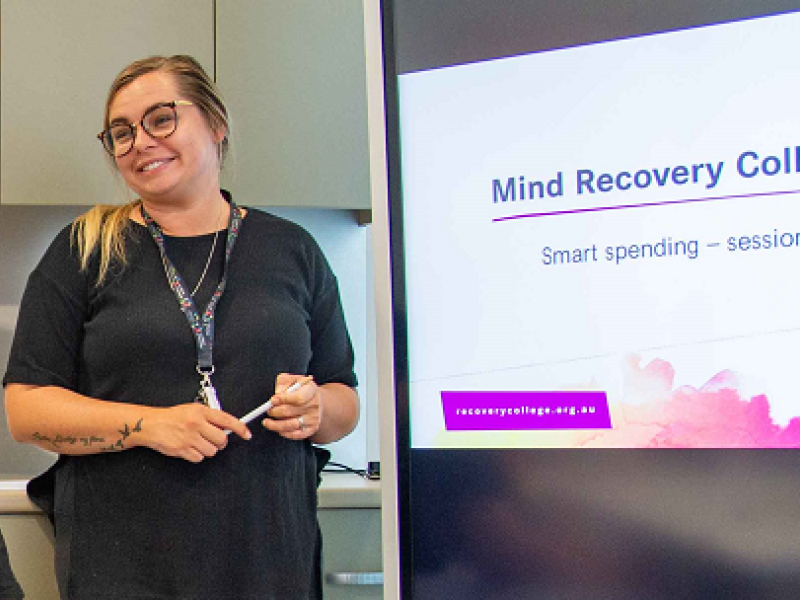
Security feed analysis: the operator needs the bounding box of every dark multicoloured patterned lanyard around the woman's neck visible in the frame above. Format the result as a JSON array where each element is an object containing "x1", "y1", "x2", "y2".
[{"x1": 141, "y1": 198, "x2": 242, "y2": 409}]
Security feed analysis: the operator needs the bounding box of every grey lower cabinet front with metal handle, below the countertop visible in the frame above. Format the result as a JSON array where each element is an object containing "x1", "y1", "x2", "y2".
[{"x1": 319, "y1": 508, "x2": 383, "y2": 600}]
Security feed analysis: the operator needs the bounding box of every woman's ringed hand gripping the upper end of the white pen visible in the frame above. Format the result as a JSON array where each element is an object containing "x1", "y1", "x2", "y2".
[{"x1": 261, "y1": 373, "x2": 322, "y2": 440}]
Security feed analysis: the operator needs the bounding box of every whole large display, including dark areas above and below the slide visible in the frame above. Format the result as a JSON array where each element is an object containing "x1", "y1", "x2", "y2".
[{"x1": 384, "y1": 0, "x2": 800, "y2": 598}]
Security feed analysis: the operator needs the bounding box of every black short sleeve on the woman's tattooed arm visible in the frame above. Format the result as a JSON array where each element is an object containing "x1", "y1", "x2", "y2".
[{"x1": 3, "y1": 228, "x2": 88, "y2": 390}]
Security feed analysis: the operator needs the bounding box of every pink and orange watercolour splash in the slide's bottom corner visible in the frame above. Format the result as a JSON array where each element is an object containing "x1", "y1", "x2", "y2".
[{"x1": 575, "y1": 357, "x2": 800, "y2": 448}]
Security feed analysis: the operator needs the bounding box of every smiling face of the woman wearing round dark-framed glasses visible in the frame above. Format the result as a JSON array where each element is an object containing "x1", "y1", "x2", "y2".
[{"x1": 108, "y1": 71, "x2": 225, "y2": 203}]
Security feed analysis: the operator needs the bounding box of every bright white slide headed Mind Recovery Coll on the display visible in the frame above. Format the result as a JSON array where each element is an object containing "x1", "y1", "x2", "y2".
[{"x1": 398, "y1": 8, "x2": 800, "y2": 448}]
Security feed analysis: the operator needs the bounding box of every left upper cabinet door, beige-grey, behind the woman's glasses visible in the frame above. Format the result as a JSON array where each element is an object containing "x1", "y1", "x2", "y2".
[{"x1": 0, "y1": 0, "x2": 214, "y2": 205}]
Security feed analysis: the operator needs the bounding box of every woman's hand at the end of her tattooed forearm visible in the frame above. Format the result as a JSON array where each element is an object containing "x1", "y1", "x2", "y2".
[{"x1": 145, "y1": 402, "x2": 252, "y2": 463}]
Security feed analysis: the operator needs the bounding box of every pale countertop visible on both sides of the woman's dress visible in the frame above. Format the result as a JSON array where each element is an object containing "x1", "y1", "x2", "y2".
[{"x1": 0, "y1": 472, "x2": 381, "y2": 514}]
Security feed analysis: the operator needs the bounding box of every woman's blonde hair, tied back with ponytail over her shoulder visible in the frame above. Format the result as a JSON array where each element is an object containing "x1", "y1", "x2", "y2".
[{"x1": 72, "y1": 54, "x2": 230, "y2": 285}]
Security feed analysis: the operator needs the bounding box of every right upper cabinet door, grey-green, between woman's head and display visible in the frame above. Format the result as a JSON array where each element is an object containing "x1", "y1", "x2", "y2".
[{"x1": 217, "y1": 0, "x2": 370, "y2": 208}]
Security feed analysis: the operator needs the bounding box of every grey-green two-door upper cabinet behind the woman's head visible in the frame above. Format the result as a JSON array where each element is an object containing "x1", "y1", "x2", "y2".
[{"x1": 0, "y1": 0, "x2": 370, "y2": 209}]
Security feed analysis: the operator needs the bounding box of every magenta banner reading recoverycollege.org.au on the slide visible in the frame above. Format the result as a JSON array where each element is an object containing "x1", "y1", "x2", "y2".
[{"x1": 442, "y1": 391, "x2": 611, "y2": 431}]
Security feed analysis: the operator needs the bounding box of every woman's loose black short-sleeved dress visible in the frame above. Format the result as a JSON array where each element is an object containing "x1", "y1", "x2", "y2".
[{"x1": 4, "y1": 195, "x2": 356, "y2": 600}]
